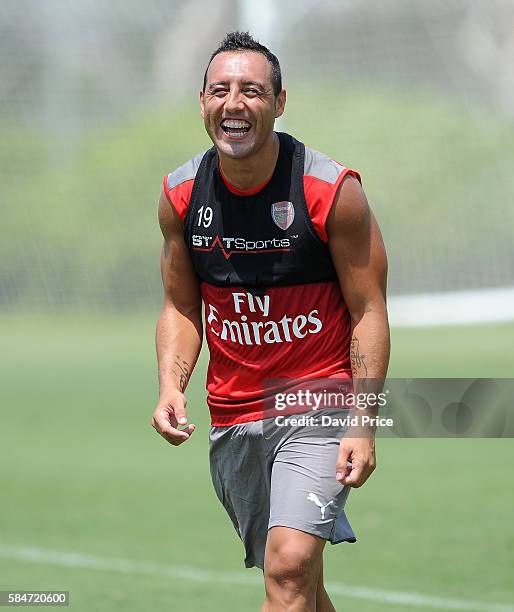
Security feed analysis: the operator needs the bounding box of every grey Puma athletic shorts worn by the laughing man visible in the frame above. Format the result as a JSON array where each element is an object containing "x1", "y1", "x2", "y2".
[{"x1": 209, "y1": 410, "x2": 356, "y2": 569}]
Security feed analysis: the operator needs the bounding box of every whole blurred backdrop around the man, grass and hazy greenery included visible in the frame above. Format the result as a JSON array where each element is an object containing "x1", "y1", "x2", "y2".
[{"x1": 0, "y1": 0, "x2": 514, "y2": 611}]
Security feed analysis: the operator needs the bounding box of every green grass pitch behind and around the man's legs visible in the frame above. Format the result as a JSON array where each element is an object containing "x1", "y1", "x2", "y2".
[{"x1": 0, "y1": 316, "x2": 514, "y2": 612}]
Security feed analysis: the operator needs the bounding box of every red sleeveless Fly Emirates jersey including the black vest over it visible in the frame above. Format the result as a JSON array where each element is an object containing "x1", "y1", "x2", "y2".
[{"x1": 164, "y1": 133, "x2": 360, "y2": 426}]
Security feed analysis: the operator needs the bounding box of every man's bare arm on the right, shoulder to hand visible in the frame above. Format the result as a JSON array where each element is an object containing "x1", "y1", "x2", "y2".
[{"x1": 327, "y1": 177, "x2": 390, "y2": 487}]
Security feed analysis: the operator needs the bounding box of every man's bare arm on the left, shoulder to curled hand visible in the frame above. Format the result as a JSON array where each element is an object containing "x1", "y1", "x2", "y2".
[{"x1": 151, "y1": 193, "x2": 202, "y2": 445}]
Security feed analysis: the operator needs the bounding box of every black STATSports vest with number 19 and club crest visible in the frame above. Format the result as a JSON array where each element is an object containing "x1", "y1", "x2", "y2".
[{"x1": 184, "y1": 133, "x2": 337, "y2": 288}]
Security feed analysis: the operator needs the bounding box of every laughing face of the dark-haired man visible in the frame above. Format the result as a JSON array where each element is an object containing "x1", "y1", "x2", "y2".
[{"x1": 200, "y1": 51, "x2": 286, "y2": 159}]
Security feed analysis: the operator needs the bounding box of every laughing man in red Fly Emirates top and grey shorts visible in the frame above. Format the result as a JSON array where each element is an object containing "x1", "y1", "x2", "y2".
[{"x1": 152, "y1": 32, "x2": 389, "y2": 612}]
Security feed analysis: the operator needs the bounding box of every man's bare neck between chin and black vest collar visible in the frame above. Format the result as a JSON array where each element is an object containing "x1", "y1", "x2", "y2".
[{"x1": 219, "y1": 132, "x2": 279, "y2": 191}]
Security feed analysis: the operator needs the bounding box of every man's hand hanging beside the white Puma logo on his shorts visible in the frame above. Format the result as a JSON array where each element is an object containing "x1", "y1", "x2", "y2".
[{"x1": 336, "y1": 434, "x2": 376, "y2": 488}]
